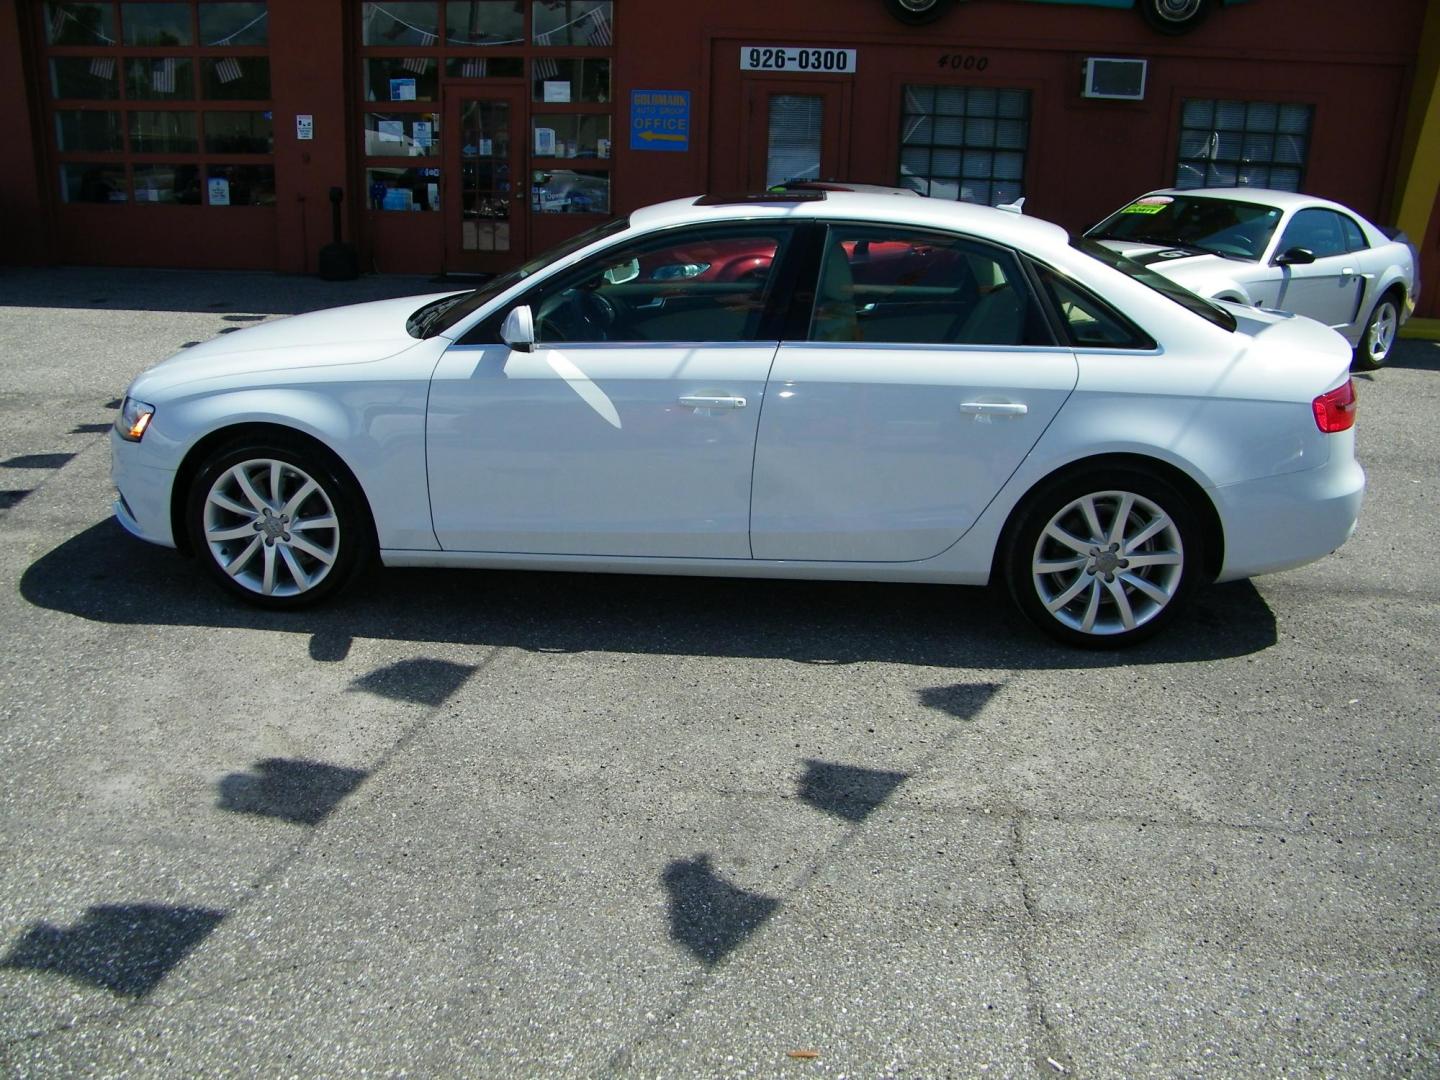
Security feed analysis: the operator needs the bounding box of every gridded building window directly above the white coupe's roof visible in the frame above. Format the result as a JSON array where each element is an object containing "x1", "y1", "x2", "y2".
[{"x1": 1175, "y1": 98, "x2": 1315, "y2": 192}]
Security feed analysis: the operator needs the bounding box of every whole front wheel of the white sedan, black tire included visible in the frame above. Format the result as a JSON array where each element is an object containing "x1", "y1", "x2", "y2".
[{"x1": 186, "y1": 438, "x2": 374, "y2": 611}]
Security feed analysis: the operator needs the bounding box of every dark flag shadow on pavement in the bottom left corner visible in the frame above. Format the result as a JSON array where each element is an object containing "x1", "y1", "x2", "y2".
[{"x1": 0, "y1": 904, "x2": 225, "y2": 998}]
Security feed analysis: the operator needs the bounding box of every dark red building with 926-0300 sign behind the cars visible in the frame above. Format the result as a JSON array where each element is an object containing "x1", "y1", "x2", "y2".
[{"x1": 0, "y1": 0, "x2": 1440, "y2": 315}]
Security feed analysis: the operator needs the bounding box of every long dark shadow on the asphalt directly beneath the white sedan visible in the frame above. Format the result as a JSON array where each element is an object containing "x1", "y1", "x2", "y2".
[{"x1": 20, "y1": 520, "x2": 1276, "y2": 670}]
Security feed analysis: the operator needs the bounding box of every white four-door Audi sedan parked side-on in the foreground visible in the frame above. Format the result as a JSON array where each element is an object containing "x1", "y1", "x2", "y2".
[{"x1": 112, "y1": 192, "x2": 1365, "y2": 645}]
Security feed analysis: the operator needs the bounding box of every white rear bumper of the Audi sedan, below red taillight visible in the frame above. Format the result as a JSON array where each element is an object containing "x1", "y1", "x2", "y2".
[{"x1": 1211, "y1": 431, "x2": 1365, "y2": 582}]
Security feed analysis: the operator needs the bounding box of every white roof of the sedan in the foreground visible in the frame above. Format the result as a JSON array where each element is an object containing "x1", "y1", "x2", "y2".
[{"x1": 631, "y1": 192, "x2": 1070, "y2": 248}]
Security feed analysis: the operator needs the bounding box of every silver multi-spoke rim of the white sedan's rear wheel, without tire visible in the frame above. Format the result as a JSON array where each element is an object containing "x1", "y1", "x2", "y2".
[{"x1": 1030, "y1": 491, "x2": 1185, "y2": 635}]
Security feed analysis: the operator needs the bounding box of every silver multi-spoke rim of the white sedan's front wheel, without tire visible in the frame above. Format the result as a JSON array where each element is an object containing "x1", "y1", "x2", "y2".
[{"x1": 204, "y1": 458, "x2": 340, "y2": 596}]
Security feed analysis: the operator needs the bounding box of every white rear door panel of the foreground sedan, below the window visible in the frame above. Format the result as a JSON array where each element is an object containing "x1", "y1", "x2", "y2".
[{"x1": 750, "y1": 341, "x2": 1077, "y2": 562}]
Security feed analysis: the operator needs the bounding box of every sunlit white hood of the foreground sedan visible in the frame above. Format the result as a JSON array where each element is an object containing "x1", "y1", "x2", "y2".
[{"x1": 131, "y1": 291, "x2": 454, "y2": 399}]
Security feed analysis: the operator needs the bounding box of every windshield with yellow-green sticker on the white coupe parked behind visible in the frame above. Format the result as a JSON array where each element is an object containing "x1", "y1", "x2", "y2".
[{"x1": 1086, "y1": 194, "x2": 1280, "y2": 261}]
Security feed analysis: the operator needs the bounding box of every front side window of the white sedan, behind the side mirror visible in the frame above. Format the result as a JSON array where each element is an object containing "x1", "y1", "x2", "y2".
[{"x1": 521, "y1": 225, "x2": 792, "y2": 344}]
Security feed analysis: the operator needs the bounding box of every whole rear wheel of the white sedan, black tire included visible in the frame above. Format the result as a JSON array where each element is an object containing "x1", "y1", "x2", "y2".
[{"x1": 1001, "y1": 469, "x2": 1205, "y2": 648}]
